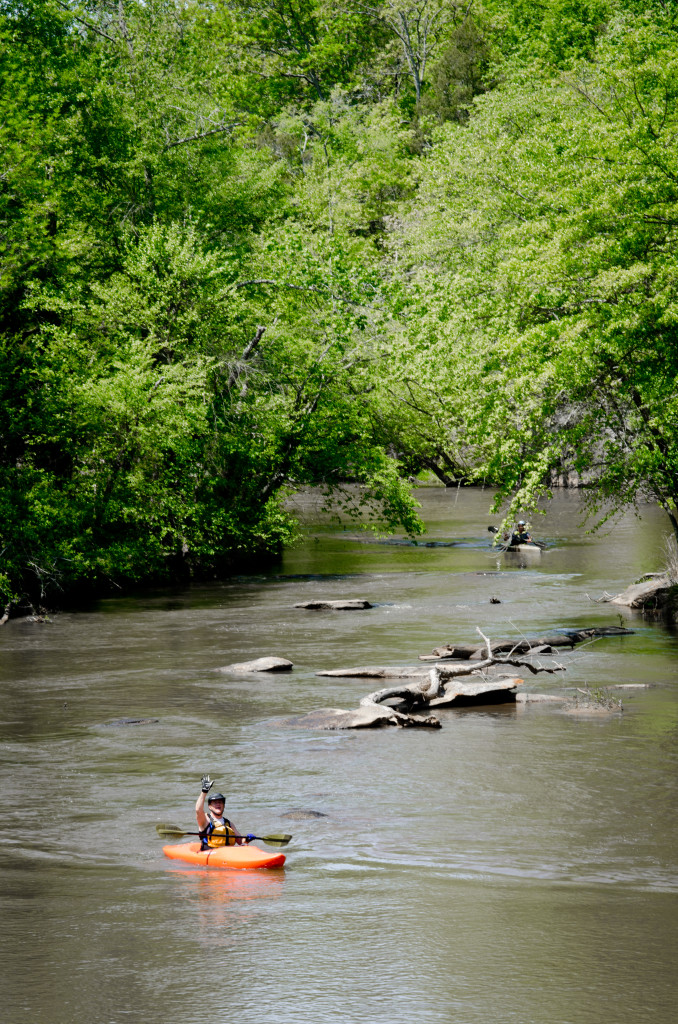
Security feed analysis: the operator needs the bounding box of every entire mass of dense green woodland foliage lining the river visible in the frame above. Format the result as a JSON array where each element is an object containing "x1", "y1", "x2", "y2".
[{"x1": 0, "y1": 0, "x2": 678, "y2": 604}]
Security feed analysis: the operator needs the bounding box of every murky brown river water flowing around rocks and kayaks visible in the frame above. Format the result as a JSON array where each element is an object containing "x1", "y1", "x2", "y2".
[{"x1": 0, "y1": 488, "x2": 678, "y2": 1024}]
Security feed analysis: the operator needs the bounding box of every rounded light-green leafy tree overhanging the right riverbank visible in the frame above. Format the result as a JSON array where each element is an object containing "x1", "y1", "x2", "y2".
[{"x1": 391, "y1": 18, "x2": 678, "y2": 529}]
